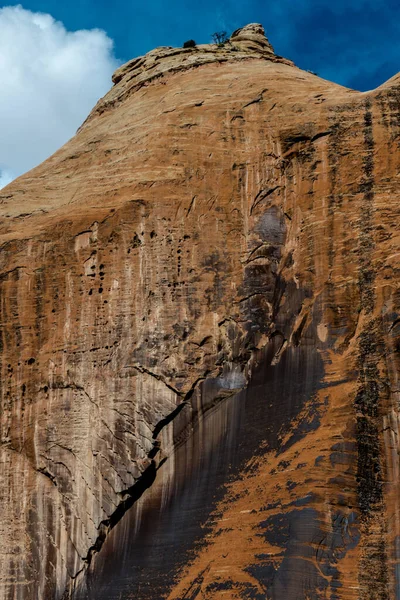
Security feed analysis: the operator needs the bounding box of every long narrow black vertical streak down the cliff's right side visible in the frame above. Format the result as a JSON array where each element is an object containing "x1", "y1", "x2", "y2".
[{"x1": 355, "y1": 100, "x2": 389, "y2": 600}]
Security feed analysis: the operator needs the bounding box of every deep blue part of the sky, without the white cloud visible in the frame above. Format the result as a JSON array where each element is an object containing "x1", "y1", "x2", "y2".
[{"x1": 5, "y1": 0, "x2": 400, "y2": 91}]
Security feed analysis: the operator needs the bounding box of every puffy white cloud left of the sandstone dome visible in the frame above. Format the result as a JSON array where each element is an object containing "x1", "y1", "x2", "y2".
[{"x1": 0, "y1": 5, "x2": 118, "y2": 188}]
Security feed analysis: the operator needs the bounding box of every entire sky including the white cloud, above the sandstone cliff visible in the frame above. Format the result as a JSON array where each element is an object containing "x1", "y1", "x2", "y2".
[{"x1": 0, "y1": 0, "x2": 400, "y2": 189}]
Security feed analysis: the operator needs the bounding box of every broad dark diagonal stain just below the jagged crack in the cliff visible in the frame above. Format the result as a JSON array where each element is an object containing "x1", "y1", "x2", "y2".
[{"x1": 74, "y1": 330, "x2": 323, "y2": 600}]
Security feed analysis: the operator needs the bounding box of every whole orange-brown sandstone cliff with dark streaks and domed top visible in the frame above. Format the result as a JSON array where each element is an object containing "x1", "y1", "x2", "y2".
[{"x1": 0, "y1": 25, "x2": 400, "y2": 600}]
